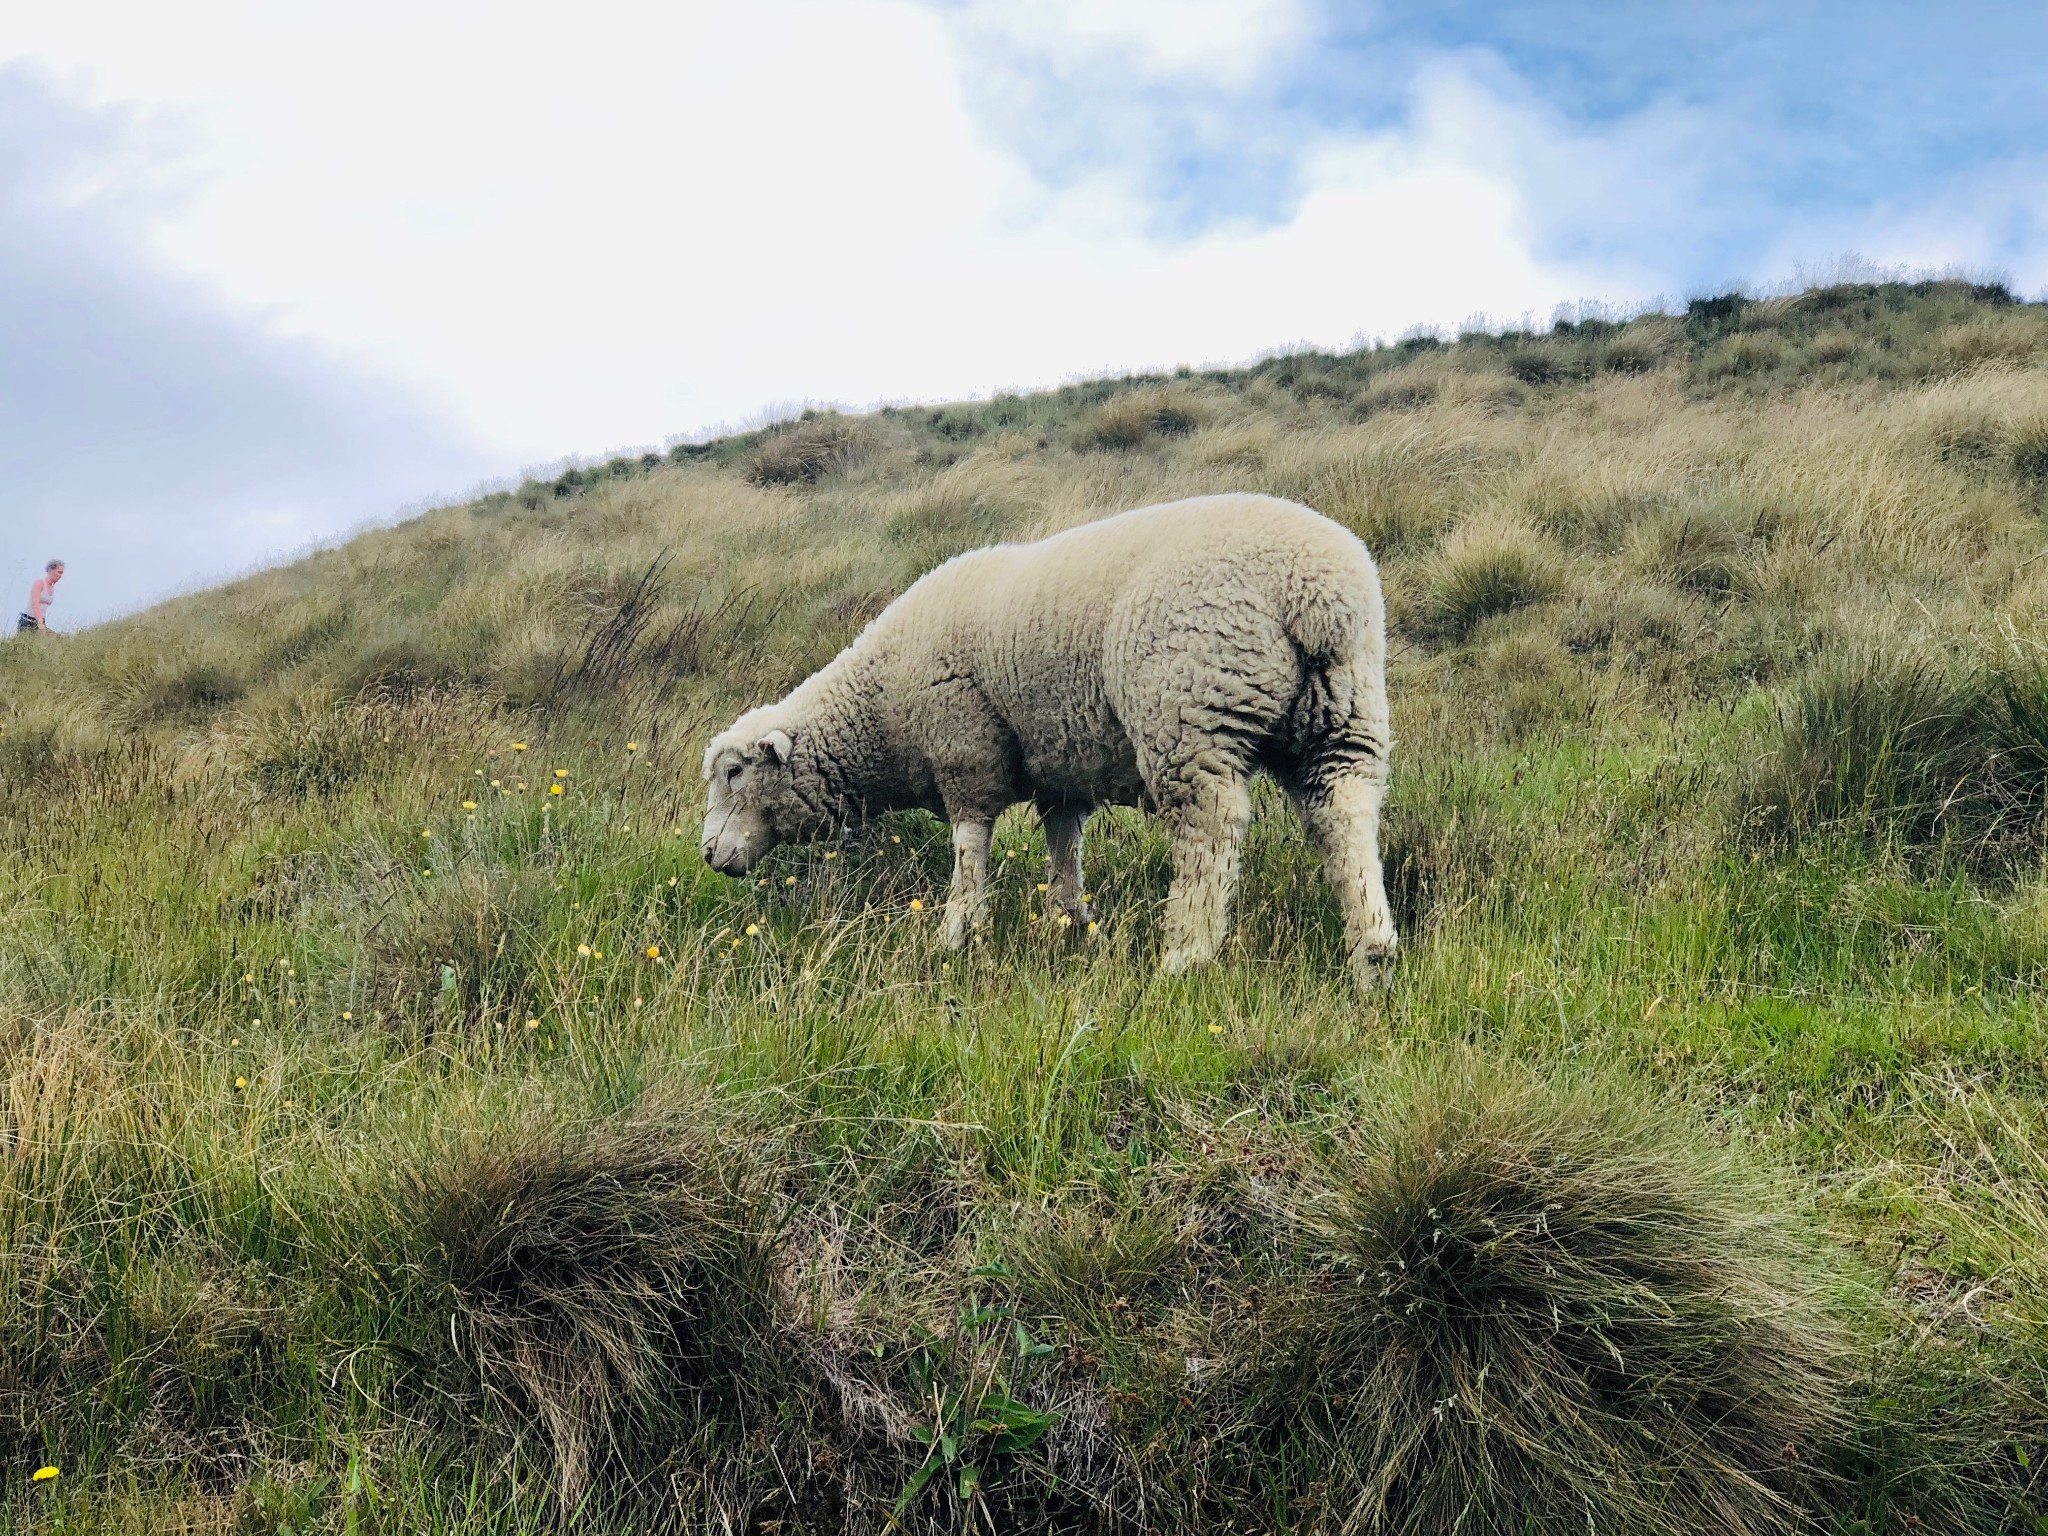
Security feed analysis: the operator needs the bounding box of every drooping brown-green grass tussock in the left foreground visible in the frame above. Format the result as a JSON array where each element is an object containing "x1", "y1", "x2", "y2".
[{"x1": 372, "y1": 1110, "x2": 774, "y2": 1509}]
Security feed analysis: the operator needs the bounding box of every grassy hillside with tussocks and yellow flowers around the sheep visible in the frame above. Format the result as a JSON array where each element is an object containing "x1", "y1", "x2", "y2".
[{"x1": 0, "y1": 283, "x2": 2048, "y2": 1536}]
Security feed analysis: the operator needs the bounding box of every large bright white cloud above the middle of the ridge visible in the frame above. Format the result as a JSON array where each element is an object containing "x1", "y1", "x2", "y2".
[{"x1": 0, "y1": 0, "x2": 1661, "y2": 487}]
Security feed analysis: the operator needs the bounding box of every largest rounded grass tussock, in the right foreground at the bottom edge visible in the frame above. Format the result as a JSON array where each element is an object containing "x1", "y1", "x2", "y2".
[{"x1": 1270, "y1": 1067, "x2": 1849, "y2": 1536}]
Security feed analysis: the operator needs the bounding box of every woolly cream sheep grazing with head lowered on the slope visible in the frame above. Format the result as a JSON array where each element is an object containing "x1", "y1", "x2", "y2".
[{"x1": 705, "y1": 496, "x2": 1395, "y2": 985}]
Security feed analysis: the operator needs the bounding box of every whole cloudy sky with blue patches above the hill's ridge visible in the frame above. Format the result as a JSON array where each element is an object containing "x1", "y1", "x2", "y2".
[{"x1": 0, "y1": 0, "x2": 2048, "y2": 627}]
